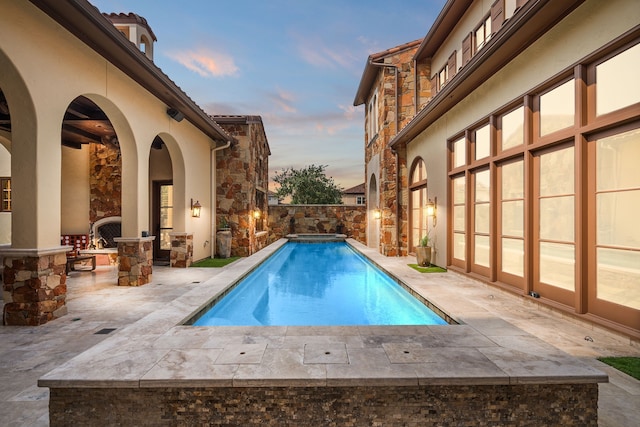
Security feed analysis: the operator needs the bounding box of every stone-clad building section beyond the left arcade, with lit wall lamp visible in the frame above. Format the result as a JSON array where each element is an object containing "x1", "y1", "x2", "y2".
[{"x1": 213, "y1": 115, "x2": 271, "y2": 256}]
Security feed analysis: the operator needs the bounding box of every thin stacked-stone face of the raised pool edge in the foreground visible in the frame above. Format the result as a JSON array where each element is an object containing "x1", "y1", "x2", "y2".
[{"x1": 49, "y1": 384, "x2": 598, "y2": 427}]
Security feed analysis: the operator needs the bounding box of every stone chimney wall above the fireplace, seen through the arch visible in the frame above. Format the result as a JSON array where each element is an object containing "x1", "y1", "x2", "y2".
[{"x1": 89, "y1": 143, "x2": 122, "y2": 223}]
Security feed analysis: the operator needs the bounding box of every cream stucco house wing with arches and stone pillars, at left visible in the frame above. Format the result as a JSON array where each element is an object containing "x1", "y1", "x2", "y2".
[{"x1": 0, "y1": 0, "x2": 245, "y2": 325}]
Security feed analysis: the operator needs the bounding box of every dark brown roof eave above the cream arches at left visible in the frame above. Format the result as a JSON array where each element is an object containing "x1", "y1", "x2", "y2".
[{"x1": 29, "y1": 0, "x2": 235, "y2": 146}]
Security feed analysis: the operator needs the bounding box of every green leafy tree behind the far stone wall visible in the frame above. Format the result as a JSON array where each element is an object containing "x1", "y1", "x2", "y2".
[{"x1": 273, "y1": 165, "x2": 342, "y2": 205}]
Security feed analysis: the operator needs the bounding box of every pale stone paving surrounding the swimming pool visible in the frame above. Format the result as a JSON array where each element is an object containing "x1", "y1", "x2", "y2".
[{"x1": 0, "y1": 239, "x2": 640, "y2": 427}]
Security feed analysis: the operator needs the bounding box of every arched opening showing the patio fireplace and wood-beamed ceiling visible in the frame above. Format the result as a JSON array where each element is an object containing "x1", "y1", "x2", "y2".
[{"x1": 60, "y1": 96, "x2": 122, "y2": 249}]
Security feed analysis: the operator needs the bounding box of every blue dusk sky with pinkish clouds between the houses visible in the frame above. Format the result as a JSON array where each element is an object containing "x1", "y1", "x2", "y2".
[{"x1": 90, "y1": 0, "x2": 445, "y2": 189}]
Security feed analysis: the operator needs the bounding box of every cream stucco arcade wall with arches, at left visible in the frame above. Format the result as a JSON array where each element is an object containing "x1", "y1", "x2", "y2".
[{"x1": 0, "y1": 1, "x2": 218, "y2": 259}]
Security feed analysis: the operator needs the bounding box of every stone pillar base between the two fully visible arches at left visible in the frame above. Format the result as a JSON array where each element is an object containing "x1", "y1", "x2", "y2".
[{"x1": 113, "y1": 236, "x2": 156, "y2": 286}]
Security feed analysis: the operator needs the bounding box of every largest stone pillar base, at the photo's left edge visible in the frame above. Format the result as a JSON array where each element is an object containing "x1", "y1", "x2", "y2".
[{"x1": 0, "y1": 246, "x2": 70, "y2": 326}]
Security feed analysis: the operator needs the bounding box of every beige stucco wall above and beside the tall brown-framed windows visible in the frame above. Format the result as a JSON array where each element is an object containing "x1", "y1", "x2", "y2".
[{"x1": 407, "y1": 0, "x2": 637, "y2": 265}]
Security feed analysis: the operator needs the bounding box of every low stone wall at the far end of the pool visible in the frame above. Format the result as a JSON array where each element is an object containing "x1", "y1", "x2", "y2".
[{"x1": 269, "y1": 205, "x2": 367, "y2": 244}]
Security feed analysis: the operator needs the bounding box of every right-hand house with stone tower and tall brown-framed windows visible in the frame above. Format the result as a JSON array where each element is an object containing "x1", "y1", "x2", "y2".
[{"x1": 354, "y1": 0, "x2": 640, "y2": 338}]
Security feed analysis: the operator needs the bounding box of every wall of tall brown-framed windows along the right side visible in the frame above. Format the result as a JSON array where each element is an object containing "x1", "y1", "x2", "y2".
[{"x1": 447, "y1": 39, "x2": 640, "y2": 333}]
